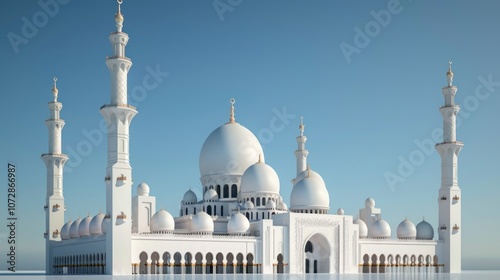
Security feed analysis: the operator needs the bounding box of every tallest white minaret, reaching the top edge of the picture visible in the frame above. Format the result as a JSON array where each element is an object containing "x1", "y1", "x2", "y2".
[{"x1": 101, "y1": 0, "x2": 137, "y2": 275}]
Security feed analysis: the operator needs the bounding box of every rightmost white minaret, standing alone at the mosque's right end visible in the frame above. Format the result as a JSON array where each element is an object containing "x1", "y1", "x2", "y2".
[{"x1": 436, "y1": 61, "x2": 464, "y2": 273}]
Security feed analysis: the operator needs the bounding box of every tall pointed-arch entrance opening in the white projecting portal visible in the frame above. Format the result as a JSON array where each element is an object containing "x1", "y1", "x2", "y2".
[{"x1": 304, "y1": 233, "x2": 331, "y2": 273}]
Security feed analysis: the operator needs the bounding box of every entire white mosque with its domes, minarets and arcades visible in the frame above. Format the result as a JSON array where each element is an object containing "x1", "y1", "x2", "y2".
[{"x1": 42, "y1": 1, "x2": 463, "y2": 275}]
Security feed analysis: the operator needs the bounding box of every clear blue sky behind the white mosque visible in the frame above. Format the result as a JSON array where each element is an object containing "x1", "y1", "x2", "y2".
[{"x1": 0, "y1": 0, "x2": 500, "y2": 270}]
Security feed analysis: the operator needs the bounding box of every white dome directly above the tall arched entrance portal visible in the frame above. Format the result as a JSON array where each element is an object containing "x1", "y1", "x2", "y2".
[{"x1": 290, "y1": 169, "x2": 330, "y2": 210}]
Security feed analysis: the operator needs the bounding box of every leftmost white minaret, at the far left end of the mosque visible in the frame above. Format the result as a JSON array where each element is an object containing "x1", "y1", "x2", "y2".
[{"x1": 42, "y1": 78, "x2": 68, "y2": 274}]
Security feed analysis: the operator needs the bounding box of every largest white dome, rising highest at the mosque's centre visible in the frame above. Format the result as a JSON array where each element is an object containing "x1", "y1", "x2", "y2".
[{"x1": 200, "y1": 122, "x2": 264, "y2": 177}]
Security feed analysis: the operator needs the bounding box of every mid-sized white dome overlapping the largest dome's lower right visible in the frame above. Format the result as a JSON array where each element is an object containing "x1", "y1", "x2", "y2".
[{"x1": 240, "y1": 160, "x2": 280, "y2": 194}]
